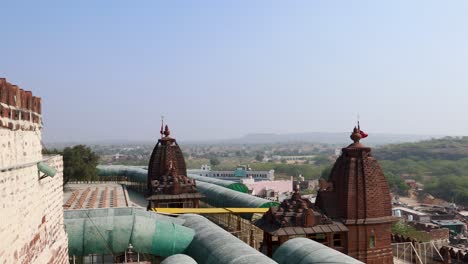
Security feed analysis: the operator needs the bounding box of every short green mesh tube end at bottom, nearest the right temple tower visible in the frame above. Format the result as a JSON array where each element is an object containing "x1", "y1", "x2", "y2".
[{"x1": 273, "y1": 237, "x2": 363, "y2": 264}]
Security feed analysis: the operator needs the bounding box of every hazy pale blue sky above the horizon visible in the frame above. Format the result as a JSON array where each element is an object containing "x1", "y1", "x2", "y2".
[{"x1": 0, "y1": 0, "x2": 468, "y2": 142}]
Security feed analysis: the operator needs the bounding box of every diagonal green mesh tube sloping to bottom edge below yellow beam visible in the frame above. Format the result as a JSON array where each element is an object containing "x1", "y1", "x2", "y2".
[{"x1": 178, "y1": 214, "x2": 276, "y2": 264}]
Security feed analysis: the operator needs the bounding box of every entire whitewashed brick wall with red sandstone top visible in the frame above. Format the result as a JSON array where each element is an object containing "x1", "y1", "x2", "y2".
[{"x1": 0, "y1": 79, "x2": 68, "y2": 264}]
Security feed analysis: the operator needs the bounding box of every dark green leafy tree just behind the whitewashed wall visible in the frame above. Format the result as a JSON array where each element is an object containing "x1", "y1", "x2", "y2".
[{"x1": 63, "y1": 145, "x2": 99, "y2": 184}]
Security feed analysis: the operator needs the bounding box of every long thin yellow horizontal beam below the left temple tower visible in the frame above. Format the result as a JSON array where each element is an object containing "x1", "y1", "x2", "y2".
[{"x1": 152, "y1": 208, "x2": 270, "y2": 214}]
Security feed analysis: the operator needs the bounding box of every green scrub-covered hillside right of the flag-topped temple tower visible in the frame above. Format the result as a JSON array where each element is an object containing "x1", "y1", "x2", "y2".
[{"x1": 373, "y1": 137, "x2": 468, "y2": 206}]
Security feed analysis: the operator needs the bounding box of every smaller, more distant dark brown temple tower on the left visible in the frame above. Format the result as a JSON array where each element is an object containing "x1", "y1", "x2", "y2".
[{"x1": 146, "y1": 126, "x2": 203, "y2": 209}]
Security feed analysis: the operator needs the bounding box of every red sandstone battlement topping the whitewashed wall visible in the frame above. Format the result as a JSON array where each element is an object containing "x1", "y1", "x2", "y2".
[{"x1": 0, "y1": 78, "x2": 42, "y2": 130}]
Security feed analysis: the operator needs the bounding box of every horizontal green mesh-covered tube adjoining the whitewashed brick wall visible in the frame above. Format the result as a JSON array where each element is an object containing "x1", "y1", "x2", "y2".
[{"x1": 64, "y1": 208, "x2": 195, "y2": 257}]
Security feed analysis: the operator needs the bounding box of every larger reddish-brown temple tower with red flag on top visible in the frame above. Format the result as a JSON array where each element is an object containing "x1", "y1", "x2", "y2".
[{"x1": 316, "y1": 127, "x2": 393, "y2": 264}]
